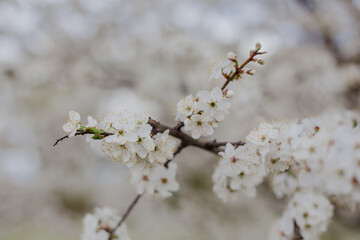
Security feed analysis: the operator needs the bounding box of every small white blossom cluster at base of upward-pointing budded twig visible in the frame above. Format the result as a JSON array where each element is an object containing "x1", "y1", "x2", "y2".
[{"x1": 176, "y1": 87, "x2": 232, "y2": 139}]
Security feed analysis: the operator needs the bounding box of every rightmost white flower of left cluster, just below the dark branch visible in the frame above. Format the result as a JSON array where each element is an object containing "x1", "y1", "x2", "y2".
[{"x1": 148, "y1": 129, "x2": 176, "y2": 163}]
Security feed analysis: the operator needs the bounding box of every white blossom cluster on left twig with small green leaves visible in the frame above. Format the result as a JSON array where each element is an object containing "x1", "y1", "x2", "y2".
[{"x1": 63, "y1": 111, "x2": 179, "y2": 197}]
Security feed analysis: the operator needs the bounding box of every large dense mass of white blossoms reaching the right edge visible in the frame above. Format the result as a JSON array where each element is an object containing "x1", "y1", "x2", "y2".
[{"x1": 213, "y1": 112, "x2": 360, "y2": 240}]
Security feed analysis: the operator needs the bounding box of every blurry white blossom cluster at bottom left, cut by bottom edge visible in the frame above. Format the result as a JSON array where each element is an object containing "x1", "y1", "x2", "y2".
[{"x1": 82, "y1": 208, "x2": 130, "y2": 240}]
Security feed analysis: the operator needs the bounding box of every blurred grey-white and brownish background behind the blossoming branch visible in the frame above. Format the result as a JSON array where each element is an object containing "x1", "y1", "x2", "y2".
[{"x1": 0, "y1": 0, "x2": 360, "y2": 240}]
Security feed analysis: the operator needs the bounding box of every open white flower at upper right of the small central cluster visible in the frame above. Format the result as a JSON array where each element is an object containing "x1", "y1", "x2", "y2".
[{"x1": 195, "y1": 87, "x2": 230, "y2": 121}]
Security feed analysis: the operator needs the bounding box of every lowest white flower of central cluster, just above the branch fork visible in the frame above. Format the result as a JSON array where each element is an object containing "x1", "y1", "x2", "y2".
[{"x1": 184, "y1": 113, "x2": 214, "y2": 139}]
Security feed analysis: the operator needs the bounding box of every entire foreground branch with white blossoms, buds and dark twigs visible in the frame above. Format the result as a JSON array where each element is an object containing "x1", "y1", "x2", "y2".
[{"x1": 54, "y1": 43, "x2": 360, "y2": 240}]
